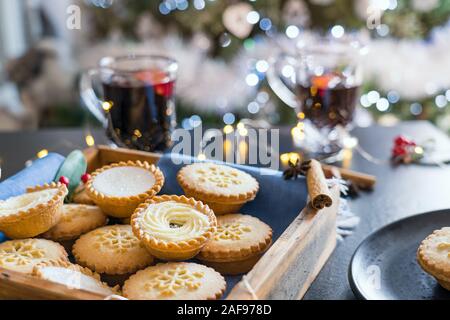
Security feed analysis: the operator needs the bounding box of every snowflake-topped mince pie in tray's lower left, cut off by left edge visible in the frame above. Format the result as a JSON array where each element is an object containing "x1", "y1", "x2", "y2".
[{"x1": 0, "y1": 239, "x2": 69, "y2": 274}]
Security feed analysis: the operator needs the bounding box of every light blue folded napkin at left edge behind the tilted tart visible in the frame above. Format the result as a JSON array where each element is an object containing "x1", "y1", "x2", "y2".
[{"x1": 0, "y1": 153, "x2": 65, "y2": 200}]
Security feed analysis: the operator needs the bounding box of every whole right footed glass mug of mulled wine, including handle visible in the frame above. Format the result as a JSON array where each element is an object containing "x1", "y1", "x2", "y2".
[{"x1": 267, "y1": 38, "x2": 362, "y2": 158}]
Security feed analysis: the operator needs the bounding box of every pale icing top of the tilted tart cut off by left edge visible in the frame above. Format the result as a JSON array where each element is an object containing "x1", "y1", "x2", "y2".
[{"x1": 0, "y1": 189, "x2": 59, "y2": 216}]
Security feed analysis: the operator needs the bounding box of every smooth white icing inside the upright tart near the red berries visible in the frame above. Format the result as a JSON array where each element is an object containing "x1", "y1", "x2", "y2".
[{"x1": 92, "y1": 166, "x2": 155, "y2": 197}]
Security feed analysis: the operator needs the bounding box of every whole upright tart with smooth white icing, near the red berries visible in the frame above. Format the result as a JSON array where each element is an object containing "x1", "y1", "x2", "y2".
[{"x1": 86, "y1": 161, "x2": 164, "y2": 218}]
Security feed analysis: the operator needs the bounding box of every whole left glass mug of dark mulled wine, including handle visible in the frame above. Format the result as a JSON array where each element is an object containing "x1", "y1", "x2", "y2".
[{"x1": 80, "y1": 55, "x2": 178, "y2": 151}]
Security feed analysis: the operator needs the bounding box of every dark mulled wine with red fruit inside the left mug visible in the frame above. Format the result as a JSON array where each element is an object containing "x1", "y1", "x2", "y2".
[{"x1": 103, "y1": 71, "x2": 175, "y2": 151}]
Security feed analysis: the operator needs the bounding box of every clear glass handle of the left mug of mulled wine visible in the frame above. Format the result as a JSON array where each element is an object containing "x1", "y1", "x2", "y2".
[{"x1": 80, "y1": 69, "x2": 108, "y2": 127}]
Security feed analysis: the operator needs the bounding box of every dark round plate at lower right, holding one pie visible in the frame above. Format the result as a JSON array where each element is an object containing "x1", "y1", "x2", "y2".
[{"x1": 349, "y1": 210, "x2": 450, "y2": 300}]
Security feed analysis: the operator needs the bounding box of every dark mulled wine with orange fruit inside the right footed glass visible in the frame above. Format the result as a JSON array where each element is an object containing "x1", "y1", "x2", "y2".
[{"x1": 297, "y1": 75, "x2": 359, "y2": 129}]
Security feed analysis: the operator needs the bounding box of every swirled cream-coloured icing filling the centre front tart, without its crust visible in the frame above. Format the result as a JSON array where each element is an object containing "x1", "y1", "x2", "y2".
[{"x1": 139, "y1": 201, "x2": 210, "y2": 242}]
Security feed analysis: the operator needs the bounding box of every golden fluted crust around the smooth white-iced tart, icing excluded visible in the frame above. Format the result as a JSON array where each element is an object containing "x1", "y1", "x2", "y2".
[{"x1": 86, "y1": 161, "x2": 164, "y2": 218}]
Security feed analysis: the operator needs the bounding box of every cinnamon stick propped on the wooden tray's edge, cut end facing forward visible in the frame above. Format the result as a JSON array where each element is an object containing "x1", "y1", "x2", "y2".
[{"x1": 306, "y1": 160, "x2": 333, "y2": 210}]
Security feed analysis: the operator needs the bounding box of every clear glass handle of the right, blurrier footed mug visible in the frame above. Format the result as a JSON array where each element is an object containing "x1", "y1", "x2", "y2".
[{"x1": 267, "y1": 54, "x2": 300, "y2": 110}]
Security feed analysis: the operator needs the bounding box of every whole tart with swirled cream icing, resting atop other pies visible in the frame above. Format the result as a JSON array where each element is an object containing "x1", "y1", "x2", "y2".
[{"x1": 131, "y1": 195, "x2": 216, "y2": 260}]
